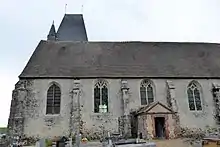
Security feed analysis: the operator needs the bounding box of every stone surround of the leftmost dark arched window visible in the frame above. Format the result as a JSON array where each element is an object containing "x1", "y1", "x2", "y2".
[{"x1": 45, "y1": 82, "x2": 62, "y2": 116}]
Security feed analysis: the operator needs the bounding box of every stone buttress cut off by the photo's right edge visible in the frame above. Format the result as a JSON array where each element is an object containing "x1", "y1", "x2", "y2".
[{"x1": 212, "y1": 83, "x2": 220, "y2": 124}]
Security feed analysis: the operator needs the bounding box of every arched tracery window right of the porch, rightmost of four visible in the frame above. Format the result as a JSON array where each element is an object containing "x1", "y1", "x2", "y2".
[{"x1": 187, "y1": 81, "x2": 202, "y2": 111}]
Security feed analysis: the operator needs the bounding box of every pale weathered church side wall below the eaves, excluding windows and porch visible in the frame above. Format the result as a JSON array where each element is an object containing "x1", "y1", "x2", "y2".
[{"x1": 8, "y1": 79, "x2": 220, "y2": 137}]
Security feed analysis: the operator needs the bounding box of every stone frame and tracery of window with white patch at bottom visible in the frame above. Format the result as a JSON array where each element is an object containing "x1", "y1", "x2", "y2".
[{"x1": 93, "y1": 79, "x2": 110, "y2": 114}]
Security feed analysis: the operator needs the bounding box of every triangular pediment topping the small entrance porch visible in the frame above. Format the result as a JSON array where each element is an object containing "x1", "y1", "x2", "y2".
[{"x1": 137, "y1": 102, "x2": 175, "y2": 114}]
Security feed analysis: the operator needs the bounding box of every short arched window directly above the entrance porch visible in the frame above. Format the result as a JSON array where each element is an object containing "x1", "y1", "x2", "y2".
[{"x1": 140, "y1": 80, "x2": 154, "y2": 105}]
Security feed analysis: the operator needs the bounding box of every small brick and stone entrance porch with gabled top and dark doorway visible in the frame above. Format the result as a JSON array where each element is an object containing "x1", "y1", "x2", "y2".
[{"x1": 133, "y1": 102, "x2": 177, "y2": 139}]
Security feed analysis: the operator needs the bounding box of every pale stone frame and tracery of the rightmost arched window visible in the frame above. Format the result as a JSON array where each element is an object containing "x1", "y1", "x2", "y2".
[{"x1": 186, "y1": 80, "x2": 204, "y2": 112}]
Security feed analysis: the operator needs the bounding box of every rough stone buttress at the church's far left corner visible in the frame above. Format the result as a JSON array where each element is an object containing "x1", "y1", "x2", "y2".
[{"x1": 8, "y1": 81, "x2": 27, "y2": 140}]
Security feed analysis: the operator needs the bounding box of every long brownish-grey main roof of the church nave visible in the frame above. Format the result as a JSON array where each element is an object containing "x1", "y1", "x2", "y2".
[{"x1": 19, "y1": 41, "x2": 220, "y2": 78}]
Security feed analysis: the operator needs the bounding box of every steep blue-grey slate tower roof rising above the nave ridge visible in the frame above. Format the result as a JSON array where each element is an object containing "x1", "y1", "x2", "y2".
[{"x1": 57, "y1": 14, "x2": 88, "y2": 41}]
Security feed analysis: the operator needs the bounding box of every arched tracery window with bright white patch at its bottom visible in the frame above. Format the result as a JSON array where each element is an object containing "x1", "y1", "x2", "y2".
[{"x1": 94, "y1": 80, "x2": 108, "y2": 113}]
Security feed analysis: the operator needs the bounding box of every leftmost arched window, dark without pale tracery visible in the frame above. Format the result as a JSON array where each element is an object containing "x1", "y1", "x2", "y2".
[{"x1": 46, "y1": 84, "x2": 61, "y2": 114}]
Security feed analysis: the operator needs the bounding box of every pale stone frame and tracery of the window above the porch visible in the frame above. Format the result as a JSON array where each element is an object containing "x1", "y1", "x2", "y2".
[{"x1": 139, "y1": 79, "x2": 156, "y2": 106}]
